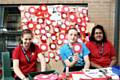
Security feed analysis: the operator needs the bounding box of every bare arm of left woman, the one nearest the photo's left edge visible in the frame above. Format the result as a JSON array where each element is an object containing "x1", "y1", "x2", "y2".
[{"x1": 13, "y1": 59, "x2": 28, "y2": 80}]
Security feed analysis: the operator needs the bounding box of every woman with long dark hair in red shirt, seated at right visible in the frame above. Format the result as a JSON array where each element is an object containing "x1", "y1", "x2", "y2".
[{"x1": 86, "y1": 25, "x2": 116, "y2": 68}]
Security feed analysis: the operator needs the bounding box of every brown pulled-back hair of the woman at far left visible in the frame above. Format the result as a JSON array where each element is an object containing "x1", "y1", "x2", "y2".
[{"x1": 20, "y1": 29, "x2": 35, "y2": 52}]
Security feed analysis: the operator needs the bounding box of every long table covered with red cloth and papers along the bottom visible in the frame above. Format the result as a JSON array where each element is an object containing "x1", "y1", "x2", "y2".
[{"x1": 29, "y1": 67, "x2": 120, "y2": 80}]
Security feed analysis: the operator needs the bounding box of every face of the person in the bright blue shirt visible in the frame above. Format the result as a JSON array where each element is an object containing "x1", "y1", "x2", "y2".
[{"x1": 67, "y1": 29, "x2": 78, "y2": 43}]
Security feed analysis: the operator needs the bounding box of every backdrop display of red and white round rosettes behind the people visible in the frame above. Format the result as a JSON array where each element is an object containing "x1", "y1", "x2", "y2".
[{"x1": 18, "y1": 5, "x2": 90, "y2": 62}]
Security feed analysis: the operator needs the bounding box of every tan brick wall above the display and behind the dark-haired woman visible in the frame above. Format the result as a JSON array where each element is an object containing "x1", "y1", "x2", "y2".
[{"x1": 0, "y1": 0, "x2": 115, "y2": 44}]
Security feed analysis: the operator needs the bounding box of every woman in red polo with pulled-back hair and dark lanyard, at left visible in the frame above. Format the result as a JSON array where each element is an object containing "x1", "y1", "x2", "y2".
[{"x1": 12, "y1": 29, "x2": 46, "y2": 80}]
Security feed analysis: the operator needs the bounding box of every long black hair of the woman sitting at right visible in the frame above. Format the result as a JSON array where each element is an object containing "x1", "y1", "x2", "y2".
[{"x1": 89, "y1": 25, "x2": 107, "y2": 42}]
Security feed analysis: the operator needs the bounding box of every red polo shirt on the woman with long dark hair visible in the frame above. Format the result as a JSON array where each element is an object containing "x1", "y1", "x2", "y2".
[{"x1": 86, "y1": 41, "x2": 116, "y2": 67}]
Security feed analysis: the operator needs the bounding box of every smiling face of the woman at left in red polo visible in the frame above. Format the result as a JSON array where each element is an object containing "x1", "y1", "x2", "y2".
[{"x1": 21, "y1": 34, "x2": 32, "y2": 49}]
